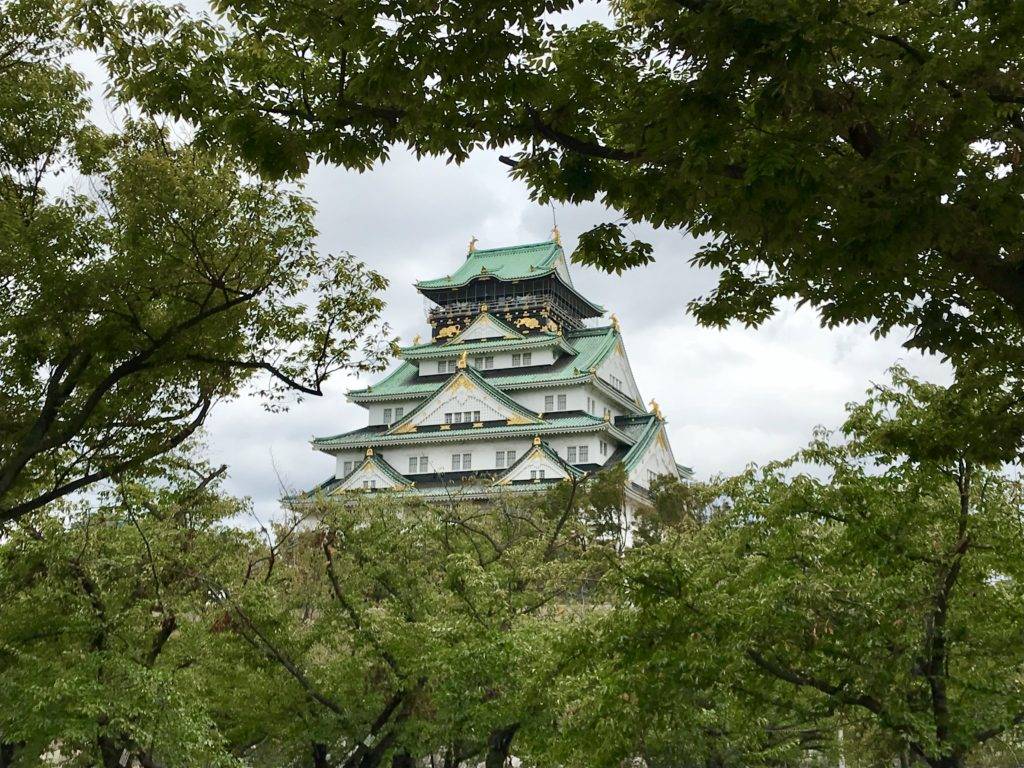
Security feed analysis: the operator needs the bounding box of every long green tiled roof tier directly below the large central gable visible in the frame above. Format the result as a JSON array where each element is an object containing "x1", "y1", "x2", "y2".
[{"x1": 312, "y1": 414, "x2": 629, "y2": 452}]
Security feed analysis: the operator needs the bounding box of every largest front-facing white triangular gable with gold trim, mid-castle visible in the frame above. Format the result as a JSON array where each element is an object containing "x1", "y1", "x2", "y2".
[{"x1": 388, "y1": 362, "x2": 542, "y2": 434}]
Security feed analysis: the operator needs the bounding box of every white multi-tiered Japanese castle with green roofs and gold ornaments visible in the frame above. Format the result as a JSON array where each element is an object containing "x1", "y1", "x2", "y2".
[{"x1": 302, "y1": 229, "x2": 689, "y2": 514}]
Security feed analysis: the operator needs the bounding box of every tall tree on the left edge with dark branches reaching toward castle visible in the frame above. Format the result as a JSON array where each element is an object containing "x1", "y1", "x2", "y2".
[{"x1": 0, "y1": 0, "x2": 387, "y2": 522}]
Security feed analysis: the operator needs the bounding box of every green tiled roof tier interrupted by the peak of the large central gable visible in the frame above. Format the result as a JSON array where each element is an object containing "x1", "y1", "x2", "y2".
[{"x1": 348, "y1": 326, "x2": 618, "y2": 402}]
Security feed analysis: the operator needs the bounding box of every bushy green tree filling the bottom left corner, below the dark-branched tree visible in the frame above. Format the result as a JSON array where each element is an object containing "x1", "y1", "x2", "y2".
[{"x1": 0, "y1": 454, "x2": 263, "y2": 768}]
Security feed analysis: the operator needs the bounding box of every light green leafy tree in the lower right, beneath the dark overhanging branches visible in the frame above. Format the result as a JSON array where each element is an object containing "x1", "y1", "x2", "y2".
[{"x1": 621, "y1": 370, "x2": 1024, "y2": 768}]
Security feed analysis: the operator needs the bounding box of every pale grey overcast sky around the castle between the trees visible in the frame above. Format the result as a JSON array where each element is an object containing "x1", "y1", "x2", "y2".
[{"x1": 79, "y1": 28, "x2": 949, "y2": 516}]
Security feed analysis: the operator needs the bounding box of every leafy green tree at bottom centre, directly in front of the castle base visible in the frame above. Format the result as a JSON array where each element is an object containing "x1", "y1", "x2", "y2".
[{"x1": 184, "y1": 481, "x2": 615, "y2": 768}]
